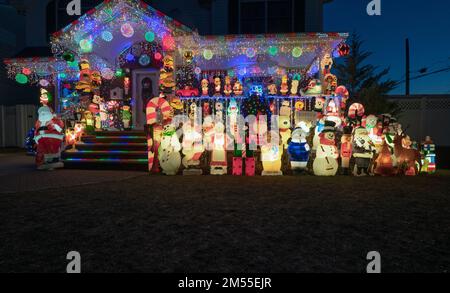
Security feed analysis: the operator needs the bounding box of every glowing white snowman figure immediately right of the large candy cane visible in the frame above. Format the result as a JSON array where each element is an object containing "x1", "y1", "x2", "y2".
[{"x1": 158, "y1": 124, "x2": 181, "y2": 175}]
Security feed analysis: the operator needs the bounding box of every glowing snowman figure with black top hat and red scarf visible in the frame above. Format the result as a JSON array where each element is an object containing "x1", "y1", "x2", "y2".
[{"x1": 313, "y1": 121, "x2": 339, "y2": 176}]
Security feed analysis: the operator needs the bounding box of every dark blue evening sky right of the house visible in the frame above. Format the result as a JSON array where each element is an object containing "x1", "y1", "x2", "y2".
[{"x1": 324, "y1": 0, "x2": 450, "y2": 94}]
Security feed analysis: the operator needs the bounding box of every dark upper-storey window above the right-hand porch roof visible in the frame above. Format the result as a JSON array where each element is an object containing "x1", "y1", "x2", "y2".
[{"x1": 229, "y1": 0, "x2": 306, "y2": 34}]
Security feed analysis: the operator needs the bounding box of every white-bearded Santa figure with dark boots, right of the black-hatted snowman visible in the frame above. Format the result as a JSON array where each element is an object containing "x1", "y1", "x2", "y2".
[{"x1": 353, "y1": 127, "x2": 375, "y2": 176}]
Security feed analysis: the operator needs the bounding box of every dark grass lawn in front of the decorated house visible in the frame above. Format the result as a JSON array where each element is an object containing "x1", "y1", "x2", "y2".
[{"x1": 0, "y1": 172, "x2": 450, "y2": 273}]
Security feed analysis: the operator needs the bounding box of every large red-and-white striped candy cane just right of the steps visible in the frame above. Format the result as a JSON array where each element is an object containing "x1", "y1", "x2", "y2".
[{"x1": 146, "y1": 95, "x2": 172, "y2": 171}]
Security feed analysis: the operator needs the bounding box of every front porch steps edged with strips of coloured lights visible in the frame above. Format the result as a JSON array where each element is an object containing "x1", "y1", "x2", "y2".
[{"x1": 62, "y1": 131, "x2": 148, "y2": 171}]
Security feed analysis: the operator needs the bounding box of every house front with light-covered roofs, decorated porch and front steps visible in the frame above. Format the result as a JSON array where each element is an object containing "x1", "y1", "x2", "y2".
[{"x1": 4, "y1": 0, "x2": 348, "y2": 171}]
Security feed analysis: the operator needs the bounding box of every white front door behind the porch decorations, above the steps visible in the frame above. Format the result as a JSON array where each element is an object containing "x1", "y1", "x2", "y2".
[{"x1": 133, "y1": 69, "x2": 159, "y2": 130}]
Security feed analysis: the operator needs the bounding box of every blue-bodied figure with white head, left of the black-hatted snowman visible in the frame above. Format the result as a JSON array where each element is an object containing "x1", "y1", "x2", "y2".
[{"x1": 288, "y1": 121, "x2": 311, "y2": 174}]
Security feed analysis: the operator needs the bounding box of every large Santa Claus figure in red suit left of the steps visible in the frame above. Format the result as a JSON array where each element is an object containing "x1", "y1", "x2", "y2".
[{"x1": 34, "y1": 106, "x2": 64, "y2": 170}]
